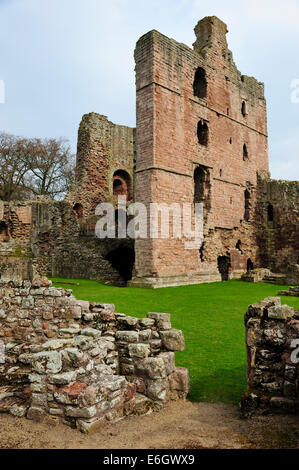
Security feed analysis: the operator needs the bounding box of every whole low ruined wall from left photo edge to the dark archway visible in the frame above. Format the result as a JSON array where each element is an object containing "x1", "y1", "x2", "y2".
[{"x1": 0, "y1": 198, "x2": 133, "y2": 285}]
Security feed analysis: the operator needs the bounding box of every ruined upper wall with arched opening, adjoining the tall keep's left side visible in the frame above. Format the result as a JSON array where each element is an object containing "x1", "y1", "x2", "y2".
[{"x1": 72, "y1": 113, "x2": 135, "y2": 217}]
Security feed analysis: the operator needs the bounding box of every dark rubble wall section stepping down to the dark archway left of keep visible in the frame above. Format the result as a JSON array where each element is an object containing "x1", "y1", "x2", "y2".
[{"x1": 31, "y1": 201, "x2": 129, "y2": 284}]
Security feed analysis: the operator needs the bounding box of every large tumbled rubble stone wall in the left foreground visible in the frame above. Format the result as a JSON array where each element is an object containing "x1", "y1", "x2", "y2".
[{"x1": 0, "y1": 277, "x2": 189, "y2": 432}]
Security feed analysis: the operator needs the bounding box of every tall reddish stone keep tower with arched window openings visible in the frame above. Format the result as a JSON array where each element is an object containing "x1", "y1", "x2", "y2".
[{"x1": 132, "y1": 16, "x2": 268, "y2": 287}]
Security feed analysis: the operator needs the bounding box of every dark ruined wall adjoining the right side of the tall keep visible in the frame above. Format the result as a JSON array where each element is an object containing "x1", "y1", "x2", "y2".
[{"x1": 255, "y1": 175, "x2": 299, "y2": 272}]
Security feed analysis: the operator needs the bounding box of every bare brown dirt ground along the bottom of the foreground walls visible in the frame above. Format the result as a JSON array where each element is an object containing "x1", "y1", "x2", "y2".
[{"x1": 0, "y1": 401, "x2": 299, "y2": 449}]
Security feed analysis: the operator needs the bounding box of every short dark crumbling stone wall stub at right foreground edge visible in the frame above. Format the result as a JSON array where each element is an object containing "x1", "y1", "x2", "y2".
[{"x1": 241, "y1": 297, "x2": 299, "y2": 417}]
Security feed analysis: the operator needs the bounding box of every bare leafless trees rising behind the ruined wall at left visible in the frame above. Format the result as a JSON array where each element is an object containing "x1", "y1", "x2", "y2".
[{"x1": 0, "y1": 133, "x2": 74, "y2": 200}]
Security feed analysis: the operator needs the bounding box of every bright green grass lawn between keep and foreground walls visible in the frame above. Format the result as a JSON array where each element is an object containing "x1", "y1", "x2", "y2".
[{"x1": 52, "y1": 279, "x2": 299, "y2": 404}]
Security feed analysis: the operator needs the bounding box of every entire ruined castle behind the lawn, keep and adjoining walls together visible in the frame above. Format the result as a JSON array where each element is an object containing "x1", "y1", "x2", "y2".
[{"x1": 0, "y1": 16, "x2": 299, "y2": 288}]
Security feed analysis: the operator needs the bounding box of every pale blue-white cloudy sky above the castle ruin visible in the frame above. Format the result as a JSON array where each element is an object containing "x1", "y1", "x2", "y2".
[{"x1": 0, "y1": 0, "x2": 299, "y2": 180}]
